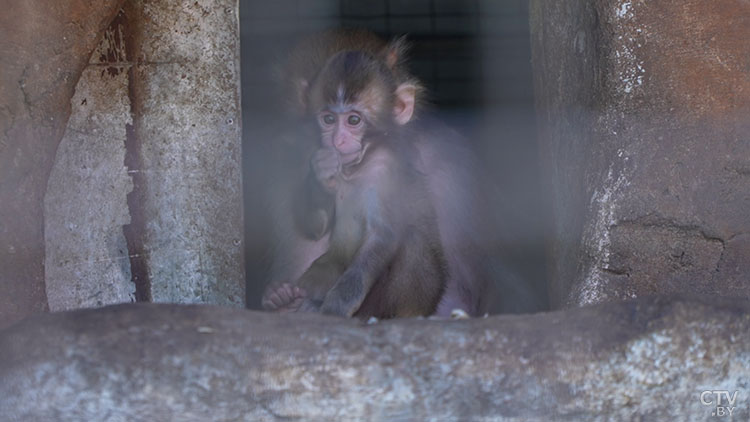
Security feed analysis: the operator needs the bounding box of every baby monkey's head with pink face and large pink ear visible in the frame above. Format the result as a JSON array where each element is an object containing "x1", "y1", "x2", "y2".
[{"x1": 307, "y1": 51, "x2": 417, "y2": 164}]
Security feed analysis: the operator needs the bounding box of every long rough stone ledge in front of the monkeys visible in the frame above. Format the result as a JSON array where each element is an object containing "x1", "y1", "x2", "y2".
[{"x1": 0, "y1": 297, "x2": 750, "y2": 422}]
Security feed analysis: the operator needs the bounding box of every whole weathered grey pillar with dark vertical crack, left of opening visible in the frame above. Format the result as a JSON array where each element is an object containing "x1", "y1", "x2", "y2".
[{"x1": 45, "y1": 0, "x2": 245, "y2": 310}]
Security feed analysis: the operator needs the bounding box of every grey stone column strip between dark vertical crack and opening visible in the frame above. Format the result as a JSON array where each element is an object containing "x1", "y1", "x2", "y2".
[{"x1": 125, "y1": 0, "x2": 245, "y2": 306}]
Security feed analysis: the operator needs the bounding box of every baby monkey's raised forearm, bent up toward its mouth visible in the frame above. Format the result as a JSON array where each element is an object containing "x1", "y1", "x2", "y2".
[{"x1": 292, "y1": 165, "x2": 335, "y2": 240}]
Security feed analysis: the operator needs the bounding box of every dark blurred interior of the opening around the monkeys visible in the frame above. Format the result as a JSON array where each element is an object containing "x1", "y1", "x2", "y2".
[{"x1": 240, "y1": 0, "x2": 549, "y2": 312}]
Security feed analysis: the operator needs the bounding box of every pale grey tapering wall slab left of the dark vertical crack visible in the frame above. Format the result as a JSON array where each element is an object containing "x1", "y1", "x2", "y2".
[{"x1": 44, "y1": 17, "x2": 135, "y2": 311}]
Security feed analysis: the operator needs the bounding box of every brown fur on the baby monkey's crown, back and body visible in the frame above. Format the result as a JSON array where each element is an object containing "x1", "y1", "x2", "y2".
[{"x1": 296, "y1": 52, "x2": 446, "y2": 318}]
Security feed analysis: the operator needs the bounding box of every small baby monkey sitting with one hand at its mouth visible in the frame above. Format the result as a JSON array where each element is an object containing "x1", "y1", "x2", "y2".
[{"x1": 263, "y1": 50, "x2": 447, "y2": 318}]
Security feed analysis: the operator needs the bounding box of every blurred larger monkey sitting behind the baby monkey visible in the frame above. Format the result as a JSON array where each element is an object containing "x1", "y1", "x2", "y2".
[{"x1": 263, "y1": 30, "x2": 490, "y2": 316}]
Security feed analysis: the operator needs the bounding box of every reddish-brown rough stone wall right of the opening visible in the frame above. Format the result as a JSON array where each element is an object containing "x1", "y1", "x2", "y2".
[{"x1": 531, "y1": 0, "x2": 750, "y2": 307}]
